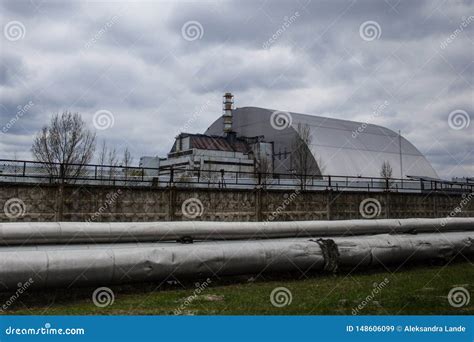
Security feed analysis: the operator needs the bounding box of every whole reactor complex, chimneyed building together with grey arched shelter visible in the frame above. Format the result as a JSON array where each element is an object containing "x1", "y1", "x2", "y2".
[{"x1": 140, "y1": 93, "x2": 439, "y2": 179}]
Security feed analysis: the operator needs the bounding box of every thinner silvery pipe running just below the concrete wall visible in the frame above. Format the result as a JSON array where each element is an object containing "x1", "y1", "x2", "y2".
[{"x1": 0, "y1": 218, "x2": 474, "y2": 246}]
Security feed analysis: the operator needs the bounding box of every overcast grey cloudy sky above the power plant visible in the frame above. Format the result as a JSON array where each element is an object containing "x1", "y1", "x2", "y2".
[{"x1": 0, "y1": 0, "x2": 474, "y2": 178}]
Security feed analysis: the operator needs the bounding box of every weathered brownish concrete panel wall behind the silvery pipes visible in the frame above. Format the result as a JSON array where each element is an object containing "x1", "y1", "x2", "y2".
[{"x1": 0, "y1": 183, "x2": 474, "y2": 222}]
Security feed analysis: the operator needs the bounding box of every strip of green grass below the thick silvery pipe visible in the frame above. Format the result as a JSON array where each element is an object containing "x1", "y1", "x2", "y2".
[{"x1": 0, "y1": 261, "x2": 474, "y2": 315}]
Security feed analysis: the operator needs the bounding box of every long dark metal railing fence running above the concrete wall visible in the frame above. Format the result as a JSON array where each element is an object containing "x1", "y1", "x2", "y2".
[{"x1": 0, "y1": 159, "x2": 474, "y2": 193}]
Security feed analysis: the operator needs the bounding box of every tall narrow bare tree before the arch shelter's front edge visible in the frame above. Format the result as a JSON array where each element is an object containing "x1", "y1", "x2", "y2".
[{"x1": 291, "y1": 123, "x2": 317, "y2": 189}]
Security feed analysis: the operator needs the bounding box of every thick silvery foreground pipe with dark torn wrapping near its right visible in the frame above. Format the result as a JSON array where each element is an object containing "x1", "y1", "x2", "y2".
[{"x1": 0, "y1": 232, "x2": 474, "y2": 289}]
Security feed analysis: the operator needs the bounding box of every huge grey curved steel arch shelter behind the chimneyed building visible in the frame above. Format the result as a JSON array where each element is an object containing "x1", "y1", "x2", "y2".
[{"x1": 206, "y1": 107, "x2": 438, "y2": 178}]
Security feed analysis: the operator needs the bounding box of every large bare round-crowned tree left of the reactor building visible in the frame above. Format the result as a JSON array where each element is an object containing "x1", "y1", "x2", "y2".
[{"x1": 31, "y1": 112, "x2": 95, "y2": 180}]
